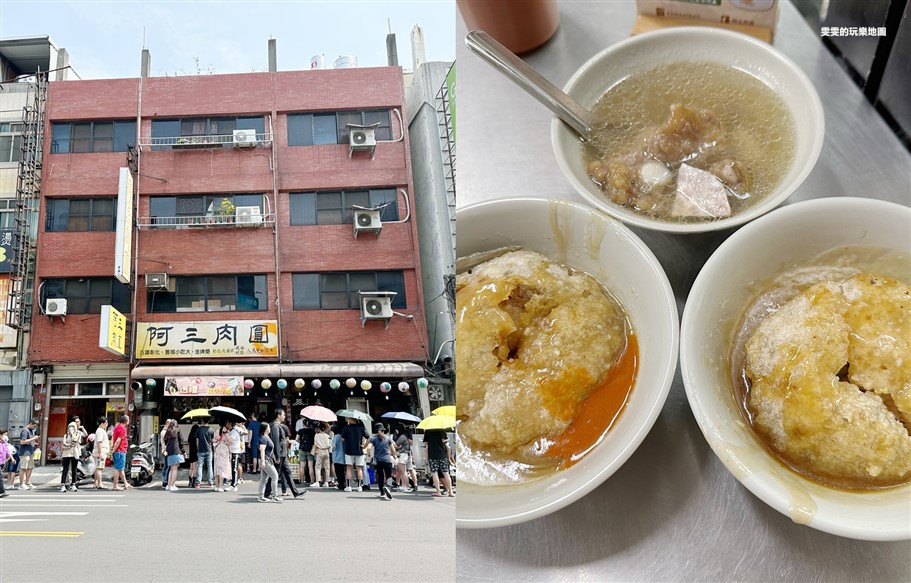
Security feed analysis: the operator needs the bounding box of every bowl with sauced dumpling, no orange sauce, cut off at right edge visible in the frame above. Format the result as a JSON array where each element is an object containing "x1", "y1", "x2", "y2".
[{"x1": 680, "y1": 198, "x2": 911, "y2": 540}]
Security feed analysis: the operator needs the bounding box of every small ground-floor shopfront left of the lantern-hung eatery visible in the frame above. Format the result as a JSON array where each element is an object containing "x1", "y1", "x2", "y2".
[{"x1": 35, "y1": 363, "x2": 131, "y2": 463}]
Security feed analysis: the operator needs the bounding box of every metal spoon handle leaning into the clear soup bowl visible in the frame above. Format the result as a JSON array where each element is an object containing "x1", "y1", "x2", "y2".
[{"x1": 465, "y1": 30, "x2": 603, "y2": 141}]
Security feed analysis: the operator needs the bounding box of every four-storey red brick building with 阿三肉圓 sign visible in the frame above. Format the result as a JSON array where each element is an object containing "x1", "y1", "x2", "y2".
[{"x1": 29, "y1": 67, "x2": 428, "y2": 458}]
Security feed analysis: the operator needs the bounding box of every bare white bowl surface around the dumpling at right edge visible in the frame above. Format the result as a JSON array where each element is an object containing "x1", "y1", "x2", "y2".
[{"x1": 680, "y1": 198, "x2": 911, "y2": 540}]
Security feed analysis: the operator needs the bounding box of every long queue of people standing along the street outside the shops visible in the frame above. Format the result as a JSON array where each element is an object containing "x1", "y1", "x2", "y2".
[{"x1": 0, "y1": 409, "x2": 455, "y2": 502}]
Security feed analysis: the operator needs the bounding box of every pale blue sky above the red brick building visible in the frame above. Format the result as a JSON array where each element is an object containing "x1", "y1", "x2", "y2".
[{"x1": 0, "y1": 0, "x2": 455, "y2": 79}]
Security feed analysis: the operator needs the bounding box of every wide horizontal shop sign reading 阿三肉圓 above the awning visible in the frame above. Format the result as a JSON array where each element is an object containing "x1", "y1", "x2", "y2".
[{"x1": 136, "y1": 320, "x2": 278, "y2": 359}]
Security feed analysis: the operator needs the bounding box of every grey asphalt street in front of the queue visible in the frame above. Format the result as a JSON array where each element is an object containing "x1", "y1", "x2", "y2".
[{"x1": 0, "y1": 466, "x2": 456, "y2": 583}]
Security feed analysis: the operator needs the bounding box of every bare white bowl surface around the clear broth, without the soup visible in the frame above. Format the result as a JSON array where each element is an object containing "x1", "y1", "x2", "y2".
[{"x1": 551, "y1": 27, "x2": 825, "y2": 233}]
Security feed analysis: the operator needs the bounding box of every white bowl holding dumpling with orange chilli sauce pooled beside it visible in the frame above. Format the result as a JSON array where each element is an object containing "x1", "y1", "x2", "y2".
[{"x1": 456, "y1": 198, "x2": 678, "y2": 528}]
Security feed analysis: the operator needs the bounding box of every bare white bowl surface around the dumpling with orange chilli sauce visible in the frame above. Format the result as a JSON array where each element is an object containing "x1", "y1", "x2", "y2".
[{"x1": 456, "y1": 198, "x2": 678, "y2": 528}]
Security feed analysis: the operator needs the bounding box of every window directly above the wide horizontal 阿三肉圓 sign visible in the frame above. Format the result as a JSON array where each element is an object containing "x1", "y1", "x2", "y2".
[{"x1": 147, "y1": 275, "x2": 269, "y2": 314}]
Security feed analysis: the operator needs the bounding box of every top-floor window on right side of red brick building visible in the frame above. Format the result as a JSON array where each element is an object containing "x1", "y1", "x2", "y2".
[{"x1": 288, "y1": 109, "x2": 392, "y2": 146}]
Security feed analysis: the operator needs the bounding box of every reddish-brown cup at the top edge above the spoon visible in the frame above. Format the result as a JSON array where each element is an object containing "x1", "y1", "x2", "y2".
[{"x1": 456, "y1": 0, "x2": 560, "y2": 53}]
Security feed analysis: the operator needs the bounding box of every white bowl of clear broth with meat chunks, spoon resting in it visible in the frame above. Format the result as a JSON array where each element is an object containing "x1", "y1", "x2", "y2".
[{"x1": 551, "y1": 27, "x2": 825, "y2": 233}]
